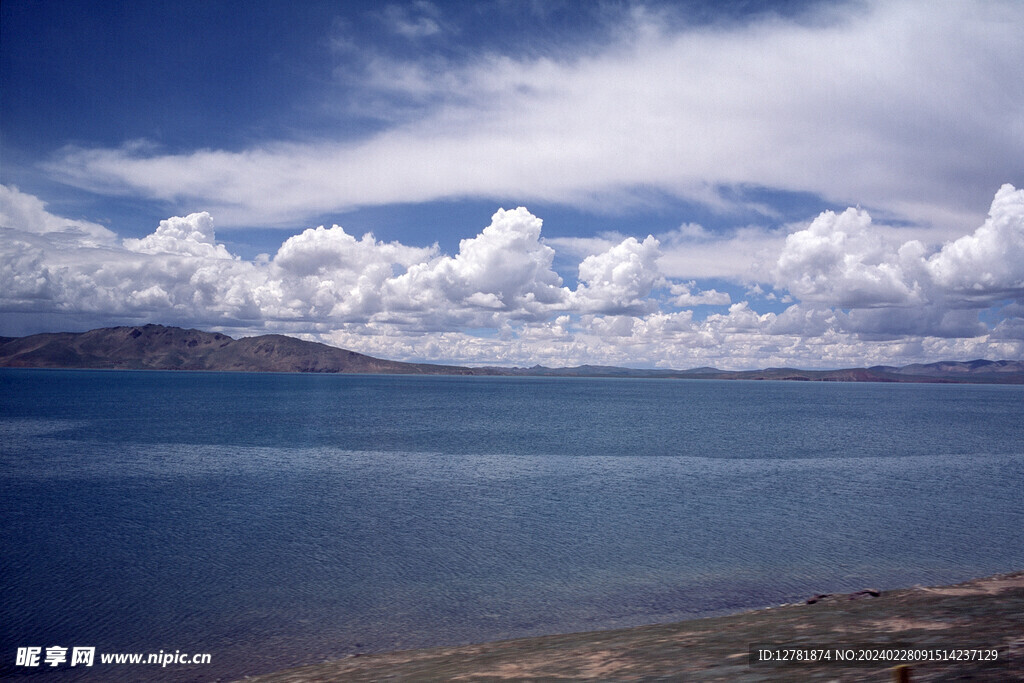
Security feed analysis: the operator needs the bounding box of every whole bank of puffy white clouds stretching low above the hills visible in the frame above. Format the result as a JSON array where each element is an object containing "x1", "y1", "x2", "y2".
[{"x1": 0, "y1": 184, "x2": 1024, "y2": 368}]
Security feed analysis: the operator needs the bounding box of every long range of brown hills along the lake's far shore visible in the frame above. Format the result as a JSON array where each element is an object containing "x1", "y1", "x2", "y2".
[{"x1": 0, "y1": 325, "x2": 1024, "y2": 384}]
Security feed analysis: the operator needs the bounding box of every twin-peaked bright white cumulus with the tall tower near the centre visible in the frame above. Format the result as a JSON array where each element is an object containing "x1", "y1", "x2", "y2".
[{"x1": 260, "y1": 208, "x2": 568, "y2": 331}]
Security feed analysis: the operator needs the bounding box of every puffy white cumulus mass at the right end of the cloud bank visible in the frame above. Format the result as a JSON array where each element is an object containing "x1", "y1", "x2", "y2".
[{"x1": 773, "y1": 184, "x2": 1024, "y2": 338}]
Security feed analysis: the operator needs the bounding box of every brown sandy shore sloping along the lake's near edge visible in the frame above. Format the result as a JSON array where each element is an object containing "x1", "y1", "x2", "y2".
[{"x1": 246, "y1": 571, "x2": 1024, "y2": 683}]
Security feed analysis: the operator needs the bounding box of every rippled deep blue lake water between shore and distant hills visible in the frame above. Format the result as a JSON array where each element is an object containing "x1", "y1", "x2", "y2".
[{"x1": 0, "y1": 370, "x2": 1024, "y2": 680}]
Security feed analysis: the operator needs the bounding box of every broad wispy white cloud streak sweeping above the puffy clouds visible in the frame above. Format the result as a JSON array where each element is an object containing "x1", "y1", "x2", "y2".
[{"x1": 47, "y1": 2, "x2": 1024, "y2": 232}]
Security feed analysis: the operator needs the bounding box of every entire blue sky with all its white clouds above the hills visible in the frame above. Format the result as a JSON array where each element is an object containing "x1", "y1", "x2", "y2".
[{"x1": 0, "y1": 0, "x2": 1024, "y2": 368}]
